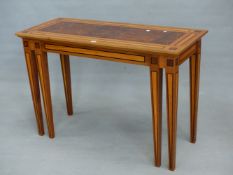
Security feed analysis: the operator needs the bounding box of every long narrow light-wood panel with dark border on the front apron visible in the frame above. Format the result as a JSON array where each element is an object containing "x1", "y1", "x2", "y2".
[{"x1": 45, "y1": 44, "x2": 145, "y2": 62}]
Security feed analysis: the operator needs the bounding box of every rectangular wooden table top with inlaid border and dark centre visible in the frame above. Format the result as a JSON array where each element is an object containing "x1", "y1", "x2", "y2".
[{"x1": 16, "y1": 18, "x2": 207, "y2": 55}]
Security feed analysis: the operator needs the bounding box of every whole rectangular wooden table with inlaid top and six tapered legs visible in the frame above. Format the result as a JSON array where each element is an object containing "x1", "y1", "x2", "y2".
[{"x1": 16, "y1": 18, "x2": 207, "y2": 170}]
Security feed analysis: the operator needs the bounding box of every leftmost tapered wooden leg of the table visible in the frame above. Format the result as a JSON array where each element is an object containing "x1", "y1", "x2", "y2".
[{"x1": 24, "y1": 46, "x2": 44, "y2": 135}]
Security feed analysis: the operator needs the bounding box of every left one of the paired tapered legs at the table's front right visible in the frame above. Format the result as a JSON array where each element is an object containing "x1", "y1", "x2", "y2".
[{"x1": 150, "y1": 68, "x2": 163, "y2": 167}]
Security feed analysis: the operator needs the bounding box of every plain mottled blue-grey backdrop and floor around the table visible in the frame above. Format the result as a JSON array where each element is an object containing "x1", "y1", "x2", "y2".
[{"x1": 0, "y1": 0, "x2": 233, "y2": 175}]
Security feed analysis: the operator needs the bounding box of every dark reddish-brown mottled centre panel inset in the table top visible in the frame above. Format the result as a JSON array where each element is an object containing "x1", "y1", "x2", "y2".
[{"x1": 41, "y1": 21, "x2": 185, "y2": 45}]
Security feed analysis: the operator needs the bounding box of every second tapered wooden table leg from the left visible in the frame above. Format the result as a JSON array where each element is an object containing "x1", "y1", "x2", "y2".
[{"x1": 36, "y1": 49, "x2": 55, "y2": 138}]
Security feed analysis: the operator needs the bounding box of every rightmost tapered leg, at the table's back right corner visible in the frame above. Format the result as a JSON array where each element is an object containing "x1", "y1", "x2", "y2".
[{"x1": 189, "y1": 43, "x2": 201, "y2": 143}]
